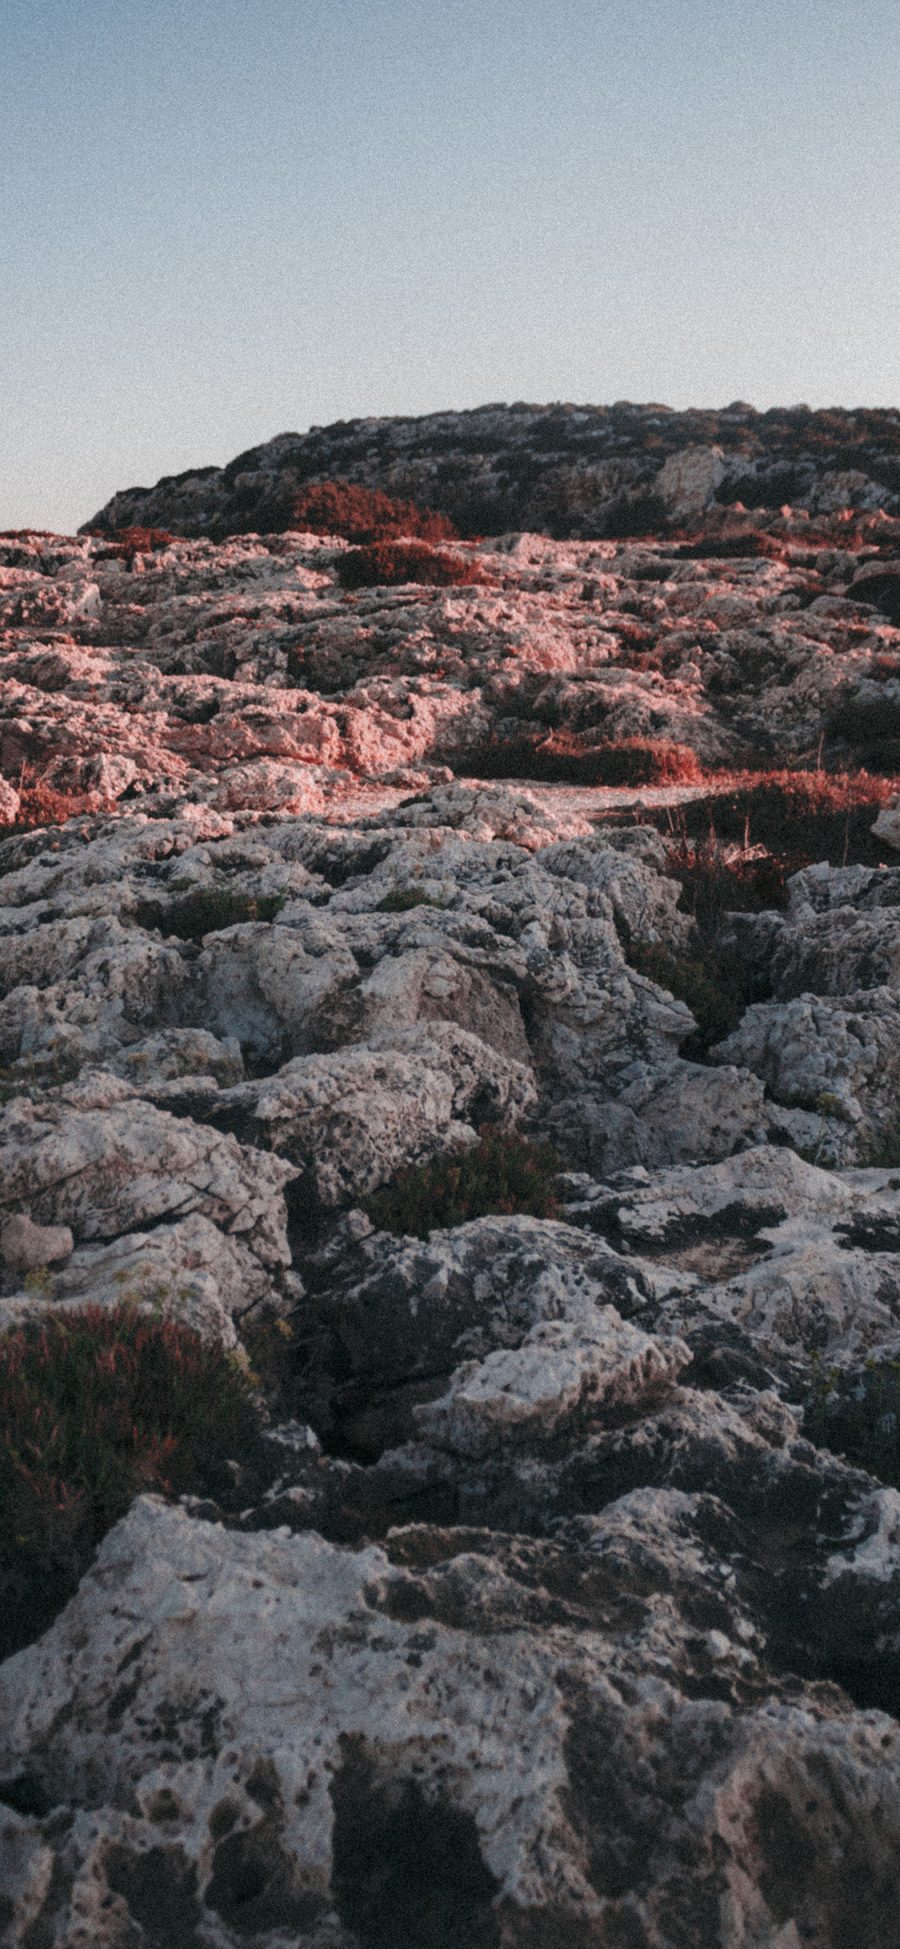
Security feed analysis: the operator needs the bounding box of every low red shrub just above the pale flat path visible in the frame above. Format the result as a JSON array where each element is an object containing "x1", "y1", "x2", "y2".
[{"x1": 464, "y1": 731, "x2": 703, "y2": 785}]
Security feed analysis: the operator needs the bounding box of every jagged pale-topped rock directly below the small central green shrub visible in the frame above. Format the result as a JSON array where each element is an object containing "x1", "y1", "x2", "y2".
[{"x1": 318, "y1": 1218, "x2": 694, "y2": 1456}]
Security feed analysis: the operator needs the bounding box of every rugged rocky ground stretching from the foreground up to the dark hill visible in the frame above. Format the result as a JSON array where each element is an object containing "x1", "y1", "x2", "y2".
[{"x1": 0, "y1": 446, "x2": 900, "y2": 1949}]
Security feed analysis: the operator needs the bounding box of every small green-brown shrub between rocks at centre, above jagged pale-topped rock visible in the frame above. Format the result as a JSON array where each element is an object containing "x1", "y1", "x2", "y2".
[{"x1": 366, "y1": 1127, "x2": 561, "y2": 1238}]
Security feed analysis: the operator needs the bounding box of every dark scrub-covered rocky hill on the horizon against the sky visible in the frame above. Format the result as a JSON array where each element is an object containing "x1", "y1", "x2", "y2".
[{"x1": 82, "y1": 401, "x2": 900, "y2": 540}]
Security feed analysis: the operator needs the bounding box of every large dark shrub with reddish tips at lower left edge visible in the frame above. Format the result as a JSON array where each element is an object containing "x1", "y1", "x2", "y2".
[{"x1": 0, "y1": 1304, "x2": 259, "y2": 1657}]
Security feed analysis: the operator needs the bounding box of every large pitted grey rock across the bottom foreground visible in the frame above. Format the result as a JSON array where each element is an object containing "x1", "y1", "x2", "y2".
[{"x1": 0, "y1": 1495, "x2": 900, "y2": 1949}]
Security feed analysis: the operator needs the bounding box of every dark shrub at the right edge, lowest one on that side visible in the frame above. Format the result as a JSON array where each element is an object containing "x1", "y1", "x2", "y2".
[{"x1": 803, "y1": 1360, "x2": 900, "y2": 1489}]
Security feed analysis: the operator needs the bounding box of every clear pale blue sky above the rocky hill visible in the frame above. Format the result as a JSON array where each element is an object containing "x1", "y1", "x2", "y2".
[{"x1": 0, "y1": 0, "x2": 900, "y2": 532}]
